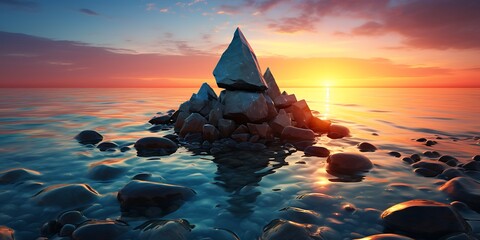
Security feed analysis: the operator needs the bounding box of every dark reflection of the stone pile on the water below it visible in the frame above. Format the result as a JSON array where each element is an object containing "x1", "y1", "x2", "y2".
[{"x1": 213, "y1": 149, "x2": 287, "y2": 217}]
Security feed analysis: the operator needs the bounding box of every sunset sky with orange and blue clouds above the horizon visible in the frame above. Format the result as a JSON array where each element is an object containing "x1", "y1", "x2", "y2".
[{"x1": 0, "y1": 0, "x2": 480, "y2": 87}]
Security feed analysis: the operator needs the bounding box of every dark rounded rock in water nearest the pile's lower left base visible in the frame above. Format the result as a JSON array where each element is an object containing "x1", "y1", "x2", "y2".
[{"x1": 134, "y1": 137, "x2": 178, "y2": 157}]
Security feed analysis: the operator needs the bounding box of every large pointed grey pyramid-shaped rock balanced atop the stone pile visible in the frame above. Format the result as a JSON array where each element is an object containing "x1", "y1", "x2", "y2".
[{"x1": 213, "y1": 28, "x2": 267, "y2": 91}]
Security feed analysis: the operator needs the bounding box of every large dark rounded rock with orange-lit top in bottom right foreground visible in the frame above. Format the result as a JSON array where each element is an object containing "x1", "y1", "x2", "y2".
[{"x1": 381, "y1": 199, "x2": 468, "y2": 238}]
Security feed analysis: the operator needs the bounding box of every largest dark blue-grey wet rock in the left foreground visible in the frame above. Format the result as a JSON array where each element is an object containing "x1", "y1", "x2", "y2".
[{"x1": 117, "y1": 180, "x2": 195, "y2": 217}]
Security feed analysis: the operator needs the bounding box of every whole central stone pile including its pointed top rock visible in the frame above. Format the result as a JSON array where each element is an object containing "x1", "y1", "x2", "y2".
[{"x1": 150, "y1": 28, "x2": 338, "y2": 150}]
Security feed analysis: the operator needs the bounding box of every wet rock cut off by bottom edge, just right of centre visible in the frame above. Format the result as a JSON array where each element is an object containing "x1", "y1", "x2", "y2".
[{"x1": 259, "y1": 219, "x2": 323, "y2": 240}]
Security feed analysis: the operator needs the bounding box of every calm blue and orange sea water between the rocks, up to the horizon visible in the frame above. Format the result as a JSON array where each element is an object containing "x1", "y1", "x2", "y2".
[{"x1": 0, "y1": 88, "x2": 480, "y2": 240}]
